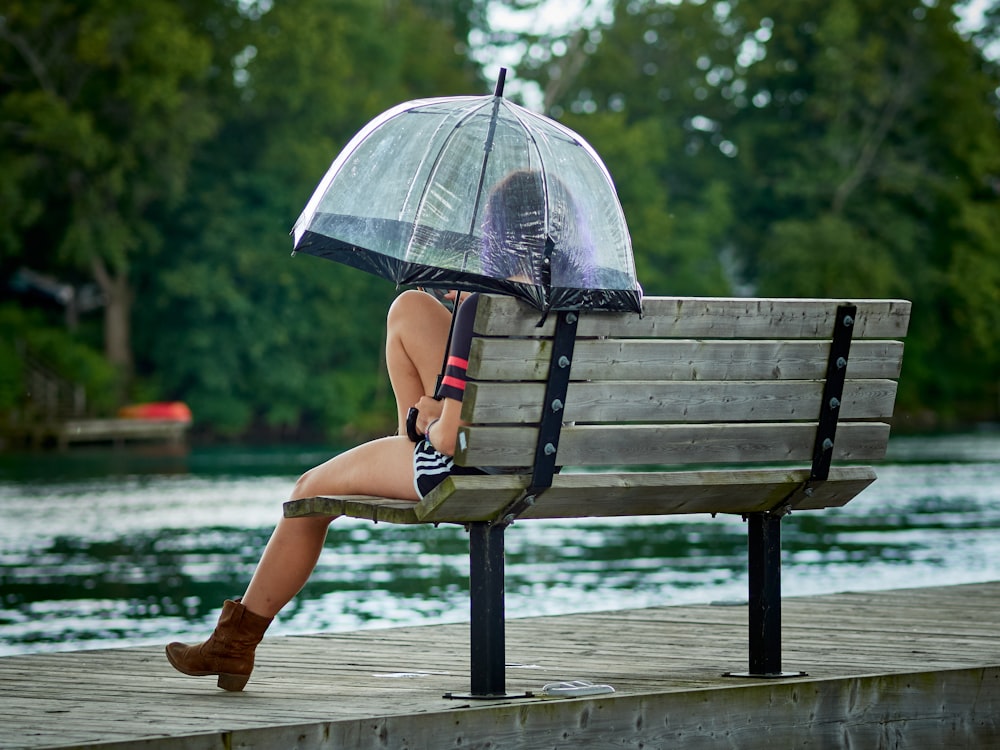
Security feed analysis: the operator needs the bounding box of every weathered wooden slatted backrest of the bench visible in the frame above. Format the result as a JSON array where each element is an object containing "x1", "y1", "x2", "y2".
[{"x1": 456, "y1": 295, "x2": 910, "y2": 467}]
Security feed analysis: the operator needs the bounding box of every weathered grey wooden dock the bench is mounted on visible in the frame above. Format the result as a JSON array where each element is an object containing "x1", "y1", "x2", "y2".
[{"x1": 0, "y1": 582, "x2": 1000, "y2": 750}]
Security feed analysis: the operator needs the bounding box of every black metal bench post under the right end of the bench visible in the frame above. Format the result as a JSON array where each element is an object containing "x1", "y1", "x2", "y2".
[{"x1": 729, "y1": 513, "x2": 805, "y2": 677}]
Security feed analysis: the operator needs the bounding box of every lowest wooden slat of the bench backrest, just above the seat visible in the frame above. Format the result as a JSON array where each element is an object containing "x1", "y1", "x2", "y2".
[{"x1": 455, "y1": 422, "x2": 889, "y2": 466}]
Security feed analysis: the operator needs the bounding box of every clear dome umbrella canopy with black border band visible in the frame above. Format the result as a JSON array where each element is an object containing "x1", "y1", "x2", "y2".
[{"x1": 292, "y1": 71, "x2": 641, "y2": 312}]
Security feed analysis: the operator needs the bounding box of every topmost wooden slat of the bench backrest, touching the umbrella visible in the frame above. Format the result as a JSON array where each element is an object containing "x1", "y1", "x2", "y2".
[{"x1": 475, "y1": 296, "x2": 911, "y2": 339}]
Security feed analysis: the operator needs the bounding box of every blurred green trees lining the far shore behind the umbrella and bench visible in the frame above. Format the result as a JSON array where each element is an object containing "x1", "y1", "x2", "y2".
[{"x1": 0, "y1": 0, "x2": 1000, "y2": 438}]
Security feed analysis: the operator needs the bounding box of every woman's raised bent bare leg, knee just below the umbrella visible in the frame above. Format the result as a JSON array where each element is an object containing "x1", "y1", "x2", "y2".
[{"x1": 385, "y1": 289, "x2": 451, "y2": 435}]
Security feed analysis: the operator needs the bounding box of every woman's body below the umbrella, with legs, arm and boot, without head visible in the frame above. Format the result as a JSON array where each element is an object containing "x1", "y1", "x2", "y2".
[{"x1": 167, "y1": 290, "x2": 478, "y2": 690}]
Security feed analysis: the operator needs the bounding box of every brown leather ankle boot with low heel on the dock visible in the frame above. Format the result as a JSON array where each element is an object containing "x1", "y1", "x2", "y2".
[{"x1": 167, "y1": 599, "x2": 273, "y2": 690}]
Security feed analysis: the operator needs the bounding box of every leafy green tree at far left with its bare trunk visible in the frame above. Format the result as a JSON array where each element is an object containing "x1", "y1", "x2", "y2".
[{"x1": 0, "y1": 0, "x2": 215, "y2": 388}]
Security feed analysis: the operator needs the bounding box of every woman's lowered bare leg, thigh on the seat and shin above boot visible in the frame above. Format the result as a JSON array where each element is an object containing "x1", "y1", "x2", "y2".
[{"x1": 243, "y1": 434, "x2": 420, "y2": 617}]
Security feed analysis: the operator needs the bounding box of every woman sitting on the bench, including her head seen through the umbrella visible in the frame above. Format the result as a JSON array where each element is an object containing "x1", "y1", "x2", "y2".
[{"x1": 167, "y1": 170, "x2": 590, "y2": 690}]
